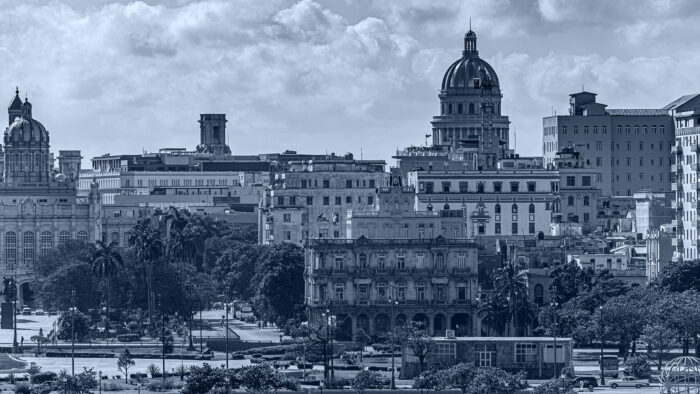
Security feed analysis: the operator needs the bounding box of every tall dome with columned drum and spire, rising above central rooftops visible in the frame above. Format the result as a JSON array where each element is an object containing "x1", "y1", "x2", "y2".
[{"x1": 431, "y1": 27, "x2": 510, "y2": 169}]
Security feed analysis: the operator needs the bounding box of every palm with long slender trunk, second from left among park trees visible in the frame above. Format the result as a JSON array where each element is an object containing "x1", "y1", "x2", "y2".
[{"x1": 129, "y1": 219, "x2": 165, "y2": 327}]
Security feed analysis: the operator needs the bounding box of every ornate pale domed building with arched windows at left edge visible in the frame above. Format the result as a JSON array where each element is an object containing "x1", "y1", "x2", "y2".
[{"x1": 0, "y1": 89, "x2": 102, "y2": 304}]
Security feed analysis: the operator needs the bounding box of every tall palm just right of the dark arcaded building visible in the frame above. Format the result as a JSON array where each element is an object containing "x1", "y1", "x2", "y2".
[{"x1": 493, "y1": 262, "x2": 532, "y2": 336}]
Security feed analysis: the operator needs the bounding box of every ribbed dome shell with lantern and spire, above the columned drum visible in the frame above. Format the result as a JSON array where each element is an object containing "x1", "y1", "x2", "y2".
[{"x1": 441, "y1": 29, "x2": 499, "y2": 90}]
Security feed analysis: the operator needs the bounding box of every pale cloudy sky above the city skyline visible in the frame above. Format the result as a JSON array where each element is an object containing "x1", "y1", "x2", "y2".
[{"x1": 0, "y1": 0, "x2": 700, "y2": 165}]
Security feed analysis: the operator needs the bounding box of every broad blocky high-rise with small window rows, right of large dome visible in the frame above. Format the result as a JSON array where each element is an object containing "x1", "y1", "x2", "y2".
[{"x1": 542, "y1": 91, "x2": 673, "y2": 197}]
